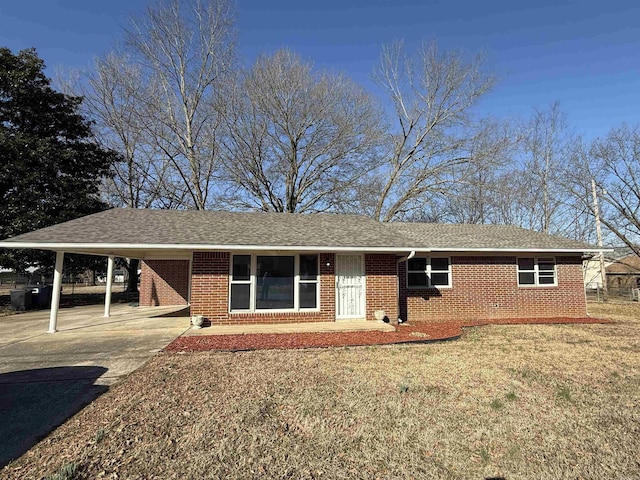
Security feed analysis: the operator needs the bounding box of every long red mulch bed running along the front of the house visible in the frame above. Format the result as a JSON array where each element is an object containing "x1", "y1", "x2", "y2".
[{"x1": 165, "y1": 317, "x2": 610, "y2": 352}]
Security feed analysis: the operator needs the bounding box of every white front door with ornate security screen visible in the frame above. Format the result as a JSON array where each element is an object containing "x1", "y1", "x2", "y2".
[{"x1": 336, "y1": 255, "x2": 365, "y2": 319}]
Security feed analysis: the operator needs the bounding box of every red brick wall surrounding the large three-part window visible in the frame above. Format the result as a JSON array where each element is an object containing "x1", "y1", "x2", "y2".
[{"x1": 191, "y1": 252, "x2": 335, "y2": 325}]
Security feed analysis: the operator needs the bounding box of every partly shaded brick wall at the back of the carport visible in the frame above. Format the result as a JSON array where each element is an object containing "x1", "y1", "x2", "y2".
[{"x1": 140, "y1": 260, "x2": 189, "y2": 307}]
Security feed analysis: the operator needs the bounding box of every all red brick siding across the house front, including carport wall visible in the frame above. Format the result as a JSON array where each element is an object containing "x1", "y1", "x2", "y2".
[{"x1": 140, "y1": 252, "x2": 586, "y2": 324}]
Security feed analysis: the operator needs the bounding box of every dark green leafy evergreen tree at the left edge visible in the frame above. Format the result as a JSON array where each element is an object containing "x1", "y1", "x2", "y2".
[{"x1": 0, "y1": 48, "x2": 118, "y2": 271}]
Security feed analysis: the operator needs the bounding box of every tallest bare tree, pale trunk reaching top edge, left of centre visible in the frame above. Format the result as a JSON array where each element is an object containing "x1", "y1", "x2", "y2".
[{"x1": 127, "y1": 0, "x2": 234, "y2": 209}]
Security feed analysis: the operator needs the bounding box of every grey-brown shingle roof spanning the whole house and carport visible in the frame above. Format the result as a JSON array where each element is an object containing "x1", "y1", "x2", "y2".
[{"x1": 0, "y1": 209, "x2": 594, "y2": 251}]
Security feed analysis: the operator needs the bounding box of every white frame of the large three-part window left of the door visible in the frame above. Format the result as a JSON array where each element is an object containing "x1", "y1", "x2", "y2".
[{"x1": 227, "y1": 252, "x2": 321, "y2": 314}]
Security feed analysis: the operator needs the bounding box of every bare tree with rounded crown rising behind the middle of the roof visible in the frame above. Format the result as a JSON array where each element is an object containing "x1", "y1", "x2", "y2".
[{"x1": 220, "y1": 50, "x2": 380, "y2": 212}]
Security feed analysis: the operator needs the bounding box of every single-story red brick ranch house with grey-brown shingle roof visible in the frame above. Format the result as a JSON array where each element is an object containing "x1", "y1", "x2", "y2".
[{"x1": 0, "y1": 209, "x2": 597, "y2": 324}]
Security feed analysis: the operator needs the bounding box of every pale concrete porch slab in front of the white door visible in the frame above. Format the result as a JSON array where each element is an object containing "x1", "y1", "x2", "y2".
[{"x1": 183, "y1": 320, "x2": 396, "y2": 336}]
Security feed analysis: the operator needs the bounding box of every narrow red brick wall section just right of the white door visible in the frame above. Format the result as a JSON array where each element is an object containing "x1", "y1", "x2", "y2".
[{"x1": 364, "y1": 254, "x2": 398, "y2": 323}]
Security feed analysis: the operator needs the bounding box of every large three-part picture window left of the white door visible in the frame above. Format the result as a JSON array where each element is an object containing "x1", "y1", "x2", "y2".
[{"x1": 229, "y1": 254, "x2": 319, "y2": 312}]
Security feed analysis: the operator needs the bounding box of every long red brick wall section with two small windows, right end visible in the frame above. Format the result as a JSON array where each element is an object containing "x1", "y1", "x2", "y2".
[{"x1": 399, "y1": 256, "x2": 586, "y2": 321}]
